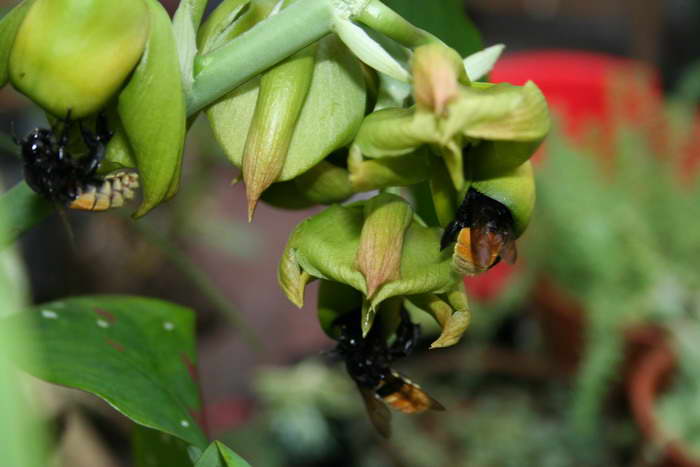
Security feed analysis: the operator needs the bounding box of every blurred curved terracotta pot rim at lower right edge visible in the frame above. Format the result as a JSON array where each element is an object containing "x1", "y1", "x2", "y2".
[{"x1": 627, "y1": 339, "x2": 700, "y2": 467}]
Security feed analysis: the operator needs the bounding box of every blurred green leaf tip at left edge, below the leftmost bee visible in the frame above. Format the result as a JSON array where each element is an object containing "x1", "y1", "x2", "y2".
[{"x1": 0, "y1": 181, "x2": 55, "y2": 250}]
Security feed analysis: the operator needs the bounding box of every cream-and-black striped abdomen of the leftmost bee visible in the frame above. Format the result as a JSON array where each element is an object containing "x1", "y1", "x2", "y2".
[{"x1": 68, "y1": 171, "x2": 139, "y2": 211}]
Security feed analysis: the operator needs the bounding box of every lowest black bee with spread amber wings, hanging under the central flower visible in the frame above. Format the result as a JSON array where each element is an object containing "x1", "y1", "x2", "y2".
[{"x1": 332, "y1": 310, "x2": 445, "y2": 438}]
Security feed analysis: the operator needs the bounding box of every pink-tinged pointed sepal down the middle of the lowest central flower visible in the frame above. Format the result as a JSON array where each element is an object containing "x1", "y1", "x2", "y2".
[{"x1": 357, "y1": 194, "x2": 413, "y2": 299}]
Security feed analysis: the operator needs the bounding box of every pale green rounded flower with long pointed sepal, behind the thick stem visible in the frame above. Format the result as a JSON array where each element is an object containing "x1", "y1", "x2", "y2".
[{"x1": 200, "y1": 2, "x2": 365, "y2": 213}]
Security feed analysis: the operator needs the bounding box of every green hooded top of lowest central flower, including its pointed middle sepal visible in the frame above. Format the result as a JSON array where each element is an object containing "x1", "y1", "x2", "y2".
[{"x1": 278, "y1": 194, "x2": 458, "y2": 326}]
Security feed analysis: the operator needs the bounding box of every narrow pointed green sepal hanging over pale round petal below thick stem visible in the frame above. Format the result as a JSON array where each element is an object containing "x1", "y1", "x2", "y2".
[{"x1": 243, "y1": 46, "x2": 316, "y2": 222}]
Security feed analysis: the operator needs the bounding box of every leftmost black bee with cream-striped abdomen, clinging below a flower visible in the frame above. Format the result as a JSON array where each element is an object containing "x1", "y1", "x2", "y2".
[{"x1": 15, "y1": 113, "x2": 139, "y2": 211}]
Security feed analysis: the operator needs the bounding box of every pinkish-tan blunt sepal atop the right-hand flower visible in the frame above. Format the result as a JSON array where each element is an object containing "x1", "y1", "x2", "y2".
[{"x1": 411, "y1": 43, "x2": 469, "y2": 116}]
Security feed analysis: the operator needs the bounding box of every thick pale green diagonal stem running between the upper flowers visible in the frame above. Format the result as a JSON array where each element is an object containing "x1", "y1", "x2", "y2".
[{"x1": 187, "y1": 0, "x2": 336, "y2": 114}]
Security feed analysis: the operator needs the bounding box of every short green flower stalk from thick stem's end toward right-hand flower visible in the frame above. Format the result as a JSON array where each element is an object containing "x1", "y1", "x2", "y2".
[{"x1": 355, "y1": 0, "x2": 442, "y2": 49}]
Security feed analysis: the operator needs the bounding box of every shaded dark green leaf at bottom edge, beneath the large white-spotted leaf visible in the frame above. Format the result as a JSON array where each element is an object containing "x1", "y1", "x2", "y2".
[{"x1": 131, "y1": 424, "x2": 192, "y2": 467}]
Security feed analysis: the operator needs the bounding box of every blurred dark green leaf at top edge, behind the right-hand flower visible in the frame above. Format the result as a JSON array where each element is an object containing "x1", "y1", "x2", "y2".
[{"x1": 383, "y1": 0, "x2": 483, "y2": 57}]
